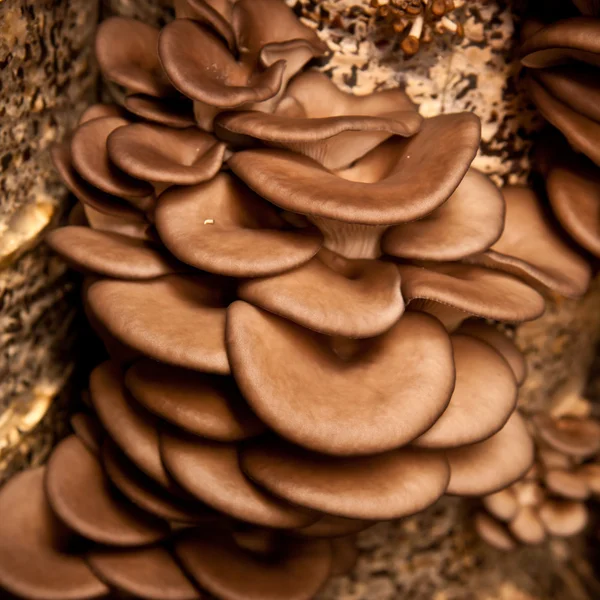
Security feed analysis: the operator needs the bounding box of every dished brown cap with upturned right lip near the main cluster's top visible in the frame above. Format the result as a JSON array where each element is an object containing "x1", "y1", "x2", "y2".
[{"x1": 158, "y1": 19, "x2": 285, "y2": 108}]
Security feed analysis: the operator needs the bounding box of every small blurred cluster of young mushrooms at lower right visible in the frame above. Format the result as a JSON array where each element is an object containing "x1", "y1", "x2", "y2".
[{"x1": 475, "y1": 413, "x2": 600, "y2": 550}]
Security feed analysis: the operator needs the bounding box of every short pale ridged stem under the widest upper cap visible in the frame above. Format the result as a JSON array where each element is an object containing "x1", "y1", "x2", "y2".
[{"x1": 309, "y1": 216, "x2": 388, "y2": 258}]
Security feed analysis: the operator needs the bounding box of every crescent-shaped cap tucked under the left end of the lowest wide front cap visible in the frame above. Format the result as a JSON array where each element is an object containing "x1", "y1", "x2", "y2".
[{"x1": 160, "y1": 431, "x2": 317, "y2": 528}]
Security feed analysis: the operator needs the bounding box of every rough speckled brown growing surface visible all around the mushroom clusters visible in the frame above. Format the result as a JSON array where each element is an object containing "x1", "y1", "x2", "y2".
[{"x1": 0, "y1": 0, "x2": 600, "y2": 600}]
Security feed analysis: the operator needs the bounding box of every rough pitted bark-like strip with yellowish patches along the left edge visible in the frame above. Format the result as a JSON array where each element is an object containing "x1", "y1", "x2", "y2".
[{"x1": 0, "y1": 0, "x2": 98, "y2": 480}]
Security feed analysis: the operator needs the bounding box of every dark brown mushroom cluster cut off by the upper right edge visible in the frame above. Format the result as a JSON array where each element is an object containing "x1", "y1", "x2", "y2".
[{"x1": 521, "y1": 0, "x2": 600, "y2": 257}]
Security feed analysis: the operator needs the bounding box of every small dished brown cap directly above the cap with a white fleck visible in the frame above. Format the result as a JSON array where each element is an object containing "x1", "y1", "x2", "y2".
[{"x1": 107, "y1": 123, "x2": 225, "y2": 185}]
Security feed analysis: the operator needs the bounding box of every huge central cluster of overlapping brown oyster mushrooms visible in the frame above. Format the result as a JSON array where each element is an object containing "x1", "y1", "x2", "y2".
[{"x1": 0, "y1": 0, "x2": 589, "y2": 600}]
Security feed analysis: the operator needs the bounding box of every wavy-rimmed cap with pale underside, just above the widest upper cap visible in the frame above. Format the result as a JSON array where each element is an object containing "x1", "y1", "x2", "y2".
[{"x1": 215, "y1": 71, "x2": 423, "y2": 170}]
